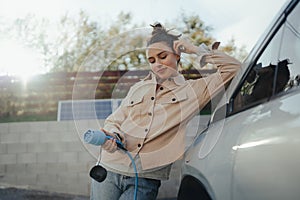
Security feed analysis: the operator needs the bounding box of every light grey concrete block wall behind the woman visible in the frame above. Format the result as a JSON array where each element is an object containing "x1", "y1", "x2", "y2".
[{"x1": 0, "y1": 116, "x2": 208, "y2": 198}]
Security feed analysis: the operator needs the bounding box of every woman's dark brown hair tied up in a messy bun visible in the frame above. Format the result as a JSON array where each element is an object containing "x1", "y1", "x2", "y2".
[{"x1": 147, "y1": 22, "x2": 181, "y2": 52}]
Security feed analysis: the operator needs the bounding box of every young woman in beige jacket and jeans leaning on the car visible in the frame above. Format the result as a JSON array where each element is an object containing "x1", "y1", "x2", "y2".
[{"x1": 91, "y1": 23, "x2": 240, "y2": 200}]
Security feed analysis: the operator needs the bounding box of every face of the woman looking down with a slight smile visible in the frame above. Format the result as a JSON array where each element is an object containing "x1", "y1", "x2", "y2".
[{"x1": 146, "y1": 42, "x2": 179, "y2": 80}]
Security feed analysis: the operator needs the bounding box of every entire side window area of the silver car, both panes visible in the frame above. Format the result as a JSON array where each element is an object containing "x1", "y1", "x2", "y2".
[{"x1": 231, "y1": 4, "x2": 300, "y2": 113}]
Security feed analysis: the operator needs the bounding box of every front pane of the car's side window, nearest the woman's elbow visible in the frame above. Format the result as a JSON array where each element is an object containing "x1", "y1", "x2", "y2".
[{"x1": 232, "y1": 26, "x2": 288, "y2": 113}]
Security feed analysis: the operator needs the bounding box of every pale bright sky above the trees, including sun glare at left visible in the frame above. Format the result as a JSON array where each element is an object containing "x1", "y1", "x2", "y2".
[{"x1": 0, "y1": 0, "x2": 286, "y2": 78}]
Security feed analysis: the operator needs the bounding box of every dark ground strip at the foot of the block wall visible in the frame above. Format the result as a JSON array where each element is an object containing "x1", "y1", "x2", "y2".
[{"x1": 0, "y1": 188, "x2": 176, "y2": 200}]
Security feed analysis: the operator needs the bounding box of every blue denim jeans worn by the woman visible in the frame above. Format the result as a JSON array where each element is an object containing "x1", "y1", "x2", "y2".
[{"x1": 90, "y1": 171, "x2": 161, "y2": 200}]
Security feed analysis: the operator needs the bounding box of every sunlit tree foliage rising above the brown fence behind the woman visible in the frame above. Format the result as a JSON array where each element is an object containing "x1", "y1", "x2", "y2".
[{"x1": 0, "y1": 11, "x2": 246, "y2": 72}]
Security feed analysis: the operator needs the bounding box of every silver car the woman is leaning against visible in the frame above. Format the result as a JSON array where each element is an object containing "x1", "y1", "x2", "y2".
[{"x1": 178, "y1": 0, "x2": 300, "y2": 200}]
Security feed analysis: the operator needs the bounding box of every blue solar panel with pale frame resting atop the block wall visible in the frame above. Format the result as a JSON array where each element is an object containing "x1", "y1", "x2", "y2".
[{"x1": 57, "y1": 99, "x2": 122, "y2": 121}]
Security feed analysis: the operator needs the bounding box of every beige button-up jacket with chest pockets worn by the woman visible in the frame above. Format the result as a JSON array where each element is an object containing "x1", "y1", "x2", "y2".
[{"x1": 101, "y1": 50, "x2": 241, "y2": 170}]
